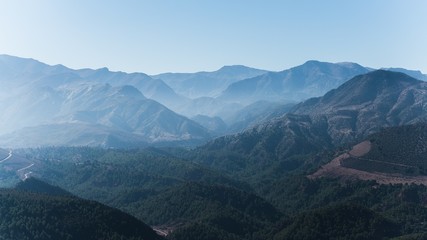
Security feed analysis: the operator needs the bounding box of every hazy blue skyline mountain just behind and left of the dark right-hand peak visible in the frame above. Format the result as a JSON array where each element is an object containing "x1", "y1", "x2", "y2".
[{"x1": 219, "y1": 61, "x2": 369, "y2": 104}]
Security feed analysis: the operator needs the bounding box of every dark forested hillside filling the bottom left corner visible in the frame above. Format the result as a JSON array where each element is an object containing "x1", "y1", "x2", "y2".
[{"x1": 0, "y1": 179, "x2": 162, "y2": 240}]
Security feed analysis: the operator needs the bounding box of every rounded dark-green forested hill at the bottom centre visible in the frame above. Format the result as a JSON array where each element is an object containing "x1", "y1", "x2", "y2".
[{"x1": 142, "y1": 183, "x2": 283, "y2": 239}]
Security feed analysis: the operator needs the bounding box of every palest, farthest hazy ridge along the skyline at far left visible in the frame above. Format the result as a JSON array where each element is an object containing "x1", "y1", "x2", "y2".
[{"x1": 0, "y1": 54, "x2": 182, "y2": 106}]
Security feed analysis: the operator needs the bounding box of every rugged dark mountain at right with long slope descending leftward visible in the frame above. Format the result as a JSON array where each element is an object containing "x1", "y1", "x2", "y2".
[{"x1": 192, "y1": 70, "x2": 427, "y2": 180}]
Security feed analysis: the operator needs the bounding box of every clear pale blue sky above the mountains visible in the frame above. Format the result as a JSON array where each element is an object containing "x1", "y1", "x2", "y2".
[{"x1": 0, "y1": 0, "x2": 427, "y2": 74}]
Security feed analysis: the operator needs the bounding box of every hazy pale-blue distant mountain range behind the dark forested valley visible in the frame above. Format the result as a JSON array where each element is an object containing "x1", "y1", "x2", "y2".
[{"x1": 0, "y1": 55, "x2": 424, "y2": 147}]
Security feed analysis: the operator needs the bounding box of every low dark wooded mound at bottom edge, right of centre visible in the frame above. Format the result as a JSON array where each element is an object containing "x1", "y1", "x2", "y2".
[{"x1": 275, "y1": 205, "x2": 399, "y2": 240}]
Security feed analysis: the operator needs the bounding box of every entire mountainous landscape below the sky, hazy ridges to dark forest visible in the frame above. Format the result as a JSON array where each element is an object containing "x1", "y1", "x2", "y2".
[{"x1": 4, "y1": 55, "x2": 427, "y2": 240}]
